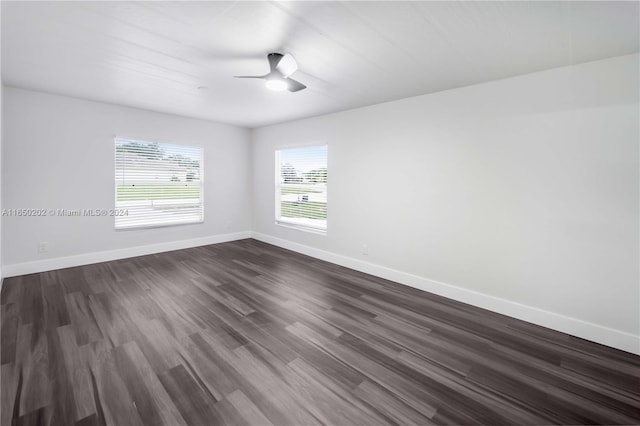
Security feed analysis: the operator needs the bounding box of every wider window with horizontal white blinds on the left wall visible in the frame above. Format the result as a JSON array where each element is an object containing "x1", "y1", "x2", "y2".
[{"x1": 115, "y1": 139, "x2": 204, "y2": 229}]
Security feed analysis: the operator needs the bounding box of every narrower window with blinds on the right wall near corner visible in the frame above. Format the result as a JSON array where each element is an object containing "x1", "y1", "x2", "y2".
[{"x1": 276, "y1": 145, "x2": 327, "y2": 233}]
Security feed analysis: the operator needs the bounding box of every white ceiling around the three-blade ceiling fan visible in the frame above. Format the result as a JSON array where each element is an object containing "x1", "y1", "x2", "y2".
[{"x1": 0, "y1": 1, "x2": 640, "y2": 127}]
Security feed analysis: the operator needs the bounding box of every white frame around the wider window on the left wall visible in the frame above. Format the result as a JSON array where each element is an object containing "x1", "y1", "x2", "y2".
[{"x1": 113, "y1": 136, "x2": 205, "y2": 232}]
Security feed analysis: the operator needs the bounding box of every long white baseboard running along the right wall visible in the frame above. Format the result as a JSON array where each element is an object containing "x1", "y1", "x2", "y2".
[{"x1": 252, "y1": 232, "x2": 640, "y2": 355}]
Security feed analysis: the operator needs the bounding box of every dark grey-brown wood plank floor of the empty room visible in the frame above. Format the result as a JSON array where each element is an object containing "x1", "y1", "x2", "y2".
[{"x1": 1, "y1": 240, "x2": 640, "y2": 426}]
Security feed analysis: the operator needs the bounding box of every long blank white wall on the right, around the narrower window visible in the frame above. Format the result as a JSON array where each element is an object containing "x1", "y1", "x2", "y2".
[{"x1": 253, "y1": 55, "x2": 640, "y2": 353}]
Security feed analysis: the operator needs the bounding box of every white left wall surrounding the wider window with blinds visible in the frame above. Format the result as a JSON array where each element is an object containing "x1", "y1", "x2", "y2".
[{"x1": 2, "y1": 87, "x2": 251, "y2": 275}]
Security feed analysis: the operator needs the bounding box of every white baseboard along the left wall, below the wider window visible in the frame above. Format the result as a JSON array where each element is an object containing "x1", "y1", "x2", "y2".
[{"x1": 2, "y1": 231, "x2": 251, "y2": 277}]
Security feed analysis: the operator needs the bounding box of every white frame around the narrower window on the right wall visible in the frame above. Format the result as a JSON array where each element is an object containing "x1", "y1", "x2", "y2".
[{"x1": 274, "y1": 142, "x2": 329, "y2": 236}]
